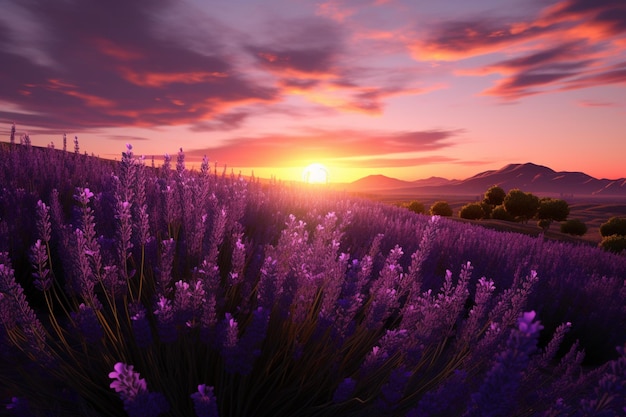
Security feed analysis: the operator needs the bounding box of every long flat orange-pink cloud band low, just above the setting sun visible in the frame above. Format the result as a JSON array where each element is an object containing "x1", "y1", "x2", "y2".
[{"x1": 185, "y1": 129, "x2": 463, "y2": 167}]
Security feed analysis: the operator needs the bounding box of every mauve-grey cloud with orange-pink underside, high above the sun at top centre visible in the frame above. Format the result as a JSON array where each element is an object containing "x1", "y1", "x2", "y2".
[{"x1": 247, "y1": 14, "x2": 441, "y2": 115}]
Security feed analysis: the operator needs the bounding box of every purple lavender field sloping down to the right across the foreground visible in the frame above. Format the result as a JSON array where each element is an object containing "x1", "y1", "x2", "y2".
[{"x1": 0, "y1": 143, "x2": 626, "y2": 417}]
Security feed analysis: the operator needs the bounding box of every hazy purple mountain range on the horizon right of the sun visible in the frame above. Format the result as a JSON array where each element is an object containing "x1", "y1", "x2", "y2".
[{"x1": 347, "y1": 163, "x2": 626, "y2": 197}]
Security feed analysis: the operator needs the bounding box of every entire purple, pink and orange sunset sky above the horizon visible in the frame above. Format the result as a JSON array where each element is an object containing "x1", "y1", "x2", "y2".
[{"x1": 0, "y1": 0, "x2": 626, "y2": 182}]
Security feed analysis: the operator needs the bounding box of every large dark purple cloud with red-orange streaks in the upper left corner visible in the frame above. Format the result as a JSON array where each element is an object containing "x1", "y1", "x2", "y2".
[{"x1": 0, "y1": 0, "x2": 279, "y2": 129}]
